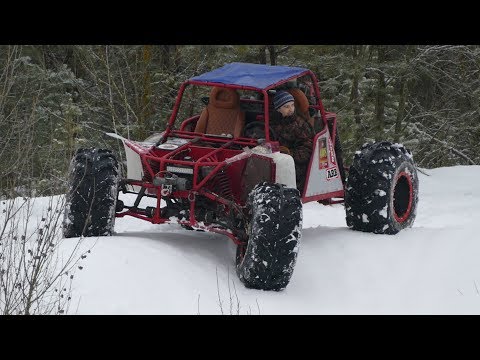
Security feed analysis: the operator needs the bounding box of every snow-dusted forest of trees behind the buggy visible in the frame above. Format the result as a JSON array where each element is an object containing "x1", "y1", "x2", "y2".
[{"x1": 0, "y1": 44, "x2": 480, "y2": 199}]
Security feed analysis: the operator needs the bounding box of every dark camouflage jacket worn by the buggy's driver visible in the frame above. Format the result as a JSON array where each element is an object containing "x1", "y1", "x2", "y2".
[{"x1": 270, "y1": 111, "x2": 315, "y2": 164}]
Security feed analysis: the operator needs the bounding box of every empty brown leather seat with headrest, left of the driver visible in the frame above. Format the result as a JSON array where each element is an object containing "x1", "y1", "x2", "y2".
[{"x1": 195, "y1": 87, "x2": 245, "y2": 137}]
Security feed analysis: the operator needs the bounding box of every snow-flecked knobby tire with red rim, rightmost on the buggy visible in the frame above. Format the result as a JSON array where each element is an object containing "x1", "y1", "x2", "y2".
[{"x1": 345, "y1": 141, "x2": 418, "y2": 234}]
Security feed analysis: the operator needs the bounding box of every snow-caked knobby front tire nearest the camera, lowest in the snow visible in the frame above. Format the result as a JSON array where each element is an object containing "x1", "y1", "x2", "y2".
[{"x1": 236, "y1": 182, "x2": 303, "y2": 291}]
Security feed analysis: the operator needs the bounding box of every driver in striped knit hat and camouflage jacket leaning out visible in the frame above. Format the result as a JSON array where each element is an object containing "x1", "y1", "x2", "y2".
[{"x1": 270, "y1": 91, "x2": 315, "y2": 194}]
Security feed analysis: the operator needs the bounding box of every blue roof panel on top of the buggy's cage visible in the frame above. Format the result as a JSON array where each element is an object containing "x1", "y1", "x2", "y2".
[{"x1": 190, "y1": 62, "x2": 308, "y2": 89}]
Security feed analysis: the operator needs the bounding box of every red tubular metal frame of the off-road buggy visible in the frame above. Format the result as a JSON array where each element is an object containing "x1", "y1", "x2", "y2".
[{"x1": 116, "y1": 70, "x2": 344, "y2": 244}]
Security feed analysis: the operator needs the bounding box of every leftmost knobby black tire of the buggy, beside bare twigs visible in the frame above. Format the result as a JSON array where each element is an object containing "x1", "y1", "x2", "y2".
[{"x1": 63, "y1": 149, "x2": 119, "y2": 238}]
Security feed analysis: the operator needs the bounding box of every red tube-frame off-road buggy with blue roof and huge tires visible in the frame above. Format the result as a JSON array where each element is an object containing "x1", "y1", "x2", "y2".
[{"x1": 64, "y1": 63, "x2": 418, "y2": 290}]
